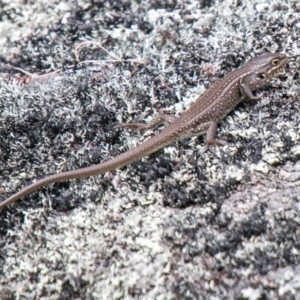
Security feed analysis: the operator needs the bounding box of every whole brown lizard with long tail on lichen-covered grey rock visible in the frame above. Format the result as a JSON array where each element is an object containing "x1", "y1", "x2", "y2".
[{"x1": 0, "y1": 52, "x2": 288, "y2": 211}]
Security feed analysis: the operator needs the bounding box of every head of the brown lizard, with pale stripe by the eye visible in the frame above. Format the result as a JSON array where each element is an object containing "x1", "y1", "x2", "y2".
[{"x1": 243, "y1": 52, "x2": 288, "y2": 90}]
